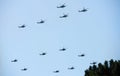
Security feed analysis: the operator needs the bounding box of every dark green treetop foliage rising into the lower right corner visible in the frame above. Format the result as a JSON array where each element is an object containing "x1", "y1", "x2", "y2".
[{"x1": 84, "y1": 59, "x2": 120, "y2": 76}]
